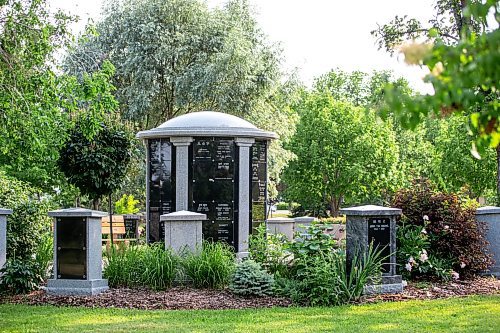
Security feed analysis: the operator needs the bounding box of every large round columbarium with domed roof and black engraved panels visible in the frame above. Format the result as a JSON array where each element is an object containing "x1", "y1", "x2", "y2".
[{"x1": 137, "y1": 111, "x2": 277, "y2": 256}]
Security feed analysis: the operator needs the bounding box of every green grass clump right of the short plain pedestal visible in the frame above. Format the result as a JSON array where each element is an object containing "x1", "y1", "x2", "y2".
[{"x1": 182, "y1": 242, "x2": 235, "y2": 289}]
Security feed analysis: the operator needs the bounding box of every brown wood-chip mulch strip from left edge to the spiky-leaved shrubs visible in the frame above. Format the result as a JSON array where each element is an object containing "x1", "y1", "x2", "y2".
[{"x1": 0, "y1": 287, "x2": 291, "y2": 310}]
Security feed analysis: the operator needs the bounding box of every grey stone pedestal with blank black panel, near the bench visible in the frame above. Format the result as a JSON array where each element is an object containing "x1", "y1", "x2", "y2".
[{"x1": 47, "y1": 208, "x2": 108, "y2": 295}]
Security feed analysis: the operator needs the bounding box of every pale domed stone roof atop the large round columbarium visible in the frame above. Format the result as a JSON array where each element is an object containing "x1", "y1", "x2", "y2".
[{"x1": 137, "y1": 111, "x2": 278, "y2": 139}]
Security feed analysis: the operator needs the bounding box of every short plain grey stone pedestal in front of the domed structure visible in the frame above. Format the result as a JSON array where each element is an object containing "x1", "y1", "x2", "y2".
[{"x1": 160, "y1": 210, "x2": 207, "y2": 253}]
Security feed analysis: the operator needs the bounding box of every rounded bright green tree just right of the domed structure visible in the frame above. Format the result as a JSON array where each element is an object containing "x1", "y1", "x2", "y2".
[{"x1": 284, "y1": 91, "x2": 398, "y2": 216}]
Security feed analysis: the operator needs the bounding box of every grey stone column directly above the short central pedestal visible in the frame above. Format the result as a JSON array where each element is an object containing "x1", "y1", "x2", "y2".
[{"x1": 170, "y1": 137, "x2": 193, "y2": 211}]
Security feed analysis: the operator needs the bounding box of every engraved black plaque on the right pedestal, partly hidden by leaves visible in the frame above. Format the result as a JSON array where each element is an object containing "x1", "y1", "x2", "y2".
[{"x1": 368, "y1": 217, "x2": 391, "y2": 273}]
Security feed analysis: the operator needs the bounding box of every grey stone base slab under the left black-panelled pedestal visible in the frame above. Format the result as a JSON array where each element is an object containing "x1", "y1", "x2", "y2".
[{"x1": 47, "y1": 279, "x2": 109, "y2": 296}]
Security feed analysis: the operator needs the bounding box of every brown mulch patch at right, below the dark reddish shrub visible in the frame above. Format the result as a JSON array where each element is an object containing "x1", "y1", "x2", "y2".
[{"x1": 361, "y1": 277, "x2": 500, "y2": 303}]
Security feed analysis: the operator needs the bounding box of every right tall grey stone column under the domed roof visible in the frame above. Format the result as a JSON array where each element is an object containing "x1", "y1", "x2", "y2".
[{"x1": 234, "y1": 138, "x2": 255, "y2": 259}]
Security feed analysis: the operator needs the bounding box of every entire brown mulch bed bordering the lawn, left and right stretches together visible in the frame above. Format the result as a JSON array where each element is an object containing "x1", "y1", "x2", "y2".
[{"x1": 0, "y1": 278, "x2": 500, "y2": 310}]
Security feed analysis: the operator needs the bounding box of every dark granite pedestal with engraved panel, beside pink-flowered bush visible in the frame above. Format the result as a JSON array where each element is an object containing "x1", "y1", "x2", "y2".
[{"x1": 340, "y1": 205, "x2": 403, "y2": 294}]
